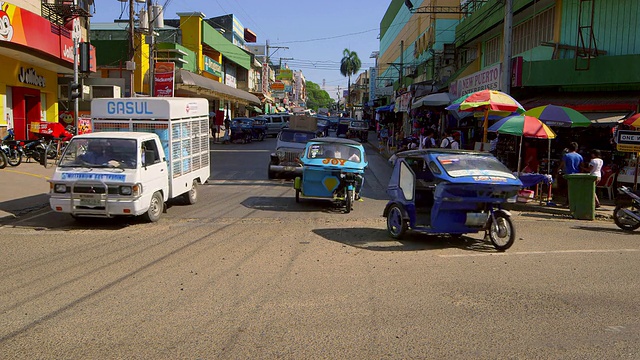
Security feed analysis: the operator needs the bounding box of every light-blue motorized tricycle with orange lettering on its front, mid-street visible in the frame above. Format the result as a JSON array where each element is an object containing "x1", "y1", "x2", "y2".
[{"x1": 294, "y1": 137, "x2": 368, "y2": 213}]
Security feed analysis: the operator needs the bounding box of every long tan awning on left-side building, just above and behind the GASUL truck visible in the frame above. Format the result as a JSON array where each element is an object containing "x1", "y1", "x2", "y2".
[{"x1": 176, "y1": 69, "x2": 260, "y2": 104}]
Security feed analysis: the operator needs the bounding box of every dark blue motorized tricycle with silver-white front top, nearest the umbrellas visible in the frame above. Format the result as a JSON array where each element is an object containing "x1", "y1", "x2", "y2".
[{"x1": 383, "y1": 149, "x2": 522, "y2": 251}]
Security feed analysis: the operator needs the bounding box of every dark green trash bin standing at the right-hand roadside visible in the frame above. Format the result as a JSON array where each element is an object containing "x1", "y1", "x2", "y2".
[{"x1": 564, "y1": 174, "x2": 597, "y2": 220}]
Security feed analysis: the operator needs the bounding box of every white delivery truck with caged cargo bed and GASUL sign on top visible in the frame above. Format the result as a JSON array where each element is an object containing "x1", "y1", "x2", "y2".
[{"x1": 49, "y1": 97, "x2": 210, "y2": 222}]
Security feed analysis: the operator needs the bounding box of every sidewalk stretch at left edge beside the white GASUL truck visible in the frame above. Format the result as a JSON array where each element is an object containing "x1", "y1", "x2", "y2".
[{"x1": 0, "y1": 159, "x2": 54, "y2": 221}]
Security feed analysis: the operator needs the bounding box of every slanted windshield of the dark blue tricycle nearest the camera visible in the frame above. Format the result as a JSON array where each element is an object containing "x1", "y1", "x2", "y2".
[{"x1": 437, "y1": 154, "x2": 516, "y2": 179}]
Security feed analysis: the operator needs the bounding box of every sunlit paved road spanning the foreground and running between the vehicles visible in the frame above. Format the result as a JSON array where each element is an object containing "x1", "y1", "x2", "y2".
[{"x1": 0, "y1": 134, "x2": 640, "y2": 359}]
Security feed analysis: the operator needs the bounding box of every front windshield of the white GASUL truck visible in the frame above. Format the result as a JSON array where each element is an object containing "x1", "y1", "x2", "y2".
[{"x1": 58, "y1": 138, "x2": 138, "y2": 169}]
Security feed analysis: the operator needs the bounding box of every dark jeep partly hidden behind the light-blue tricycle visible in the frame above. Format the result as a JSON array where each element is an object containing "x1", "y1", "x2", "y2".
[{"x1": 268, "y1": 129, "x2": 316, "y2": 179}]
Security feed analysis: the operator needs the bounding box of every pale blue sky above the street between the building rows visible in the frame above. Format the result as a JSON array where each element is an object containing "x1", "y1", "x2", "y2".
[{"x1": 91, "y1": 0, "x2": 391, "y2": 99}]
